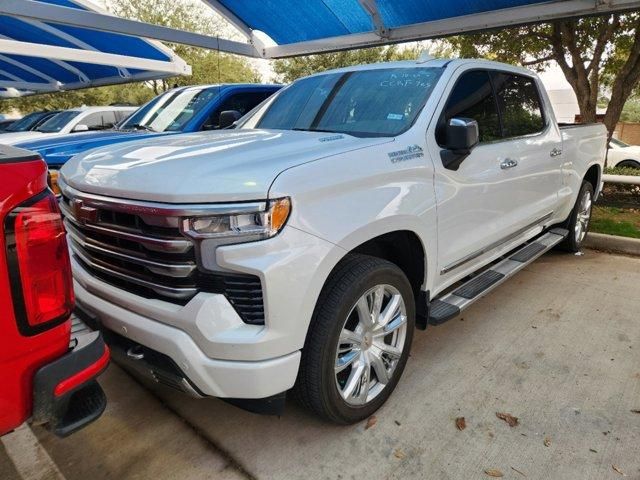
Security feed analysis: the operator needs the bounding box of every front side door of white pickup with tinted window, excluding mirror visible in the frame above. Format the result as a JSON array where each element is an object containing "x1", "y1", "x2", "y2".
[{"x1": 427, "y1": 69, "x2": 516, "y2": 281}]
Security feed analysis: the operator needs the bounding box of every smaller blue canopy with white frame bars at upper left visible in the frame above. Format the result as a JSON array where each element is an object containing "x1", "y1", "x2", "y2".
[{"x1": 0, "y1": 0, "x2": 191, "y2": 97}]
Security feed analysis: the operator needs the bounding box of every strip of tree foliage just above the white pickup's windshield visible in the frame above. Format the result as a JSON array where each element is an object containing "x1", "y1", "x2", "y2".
[{"x1": 273, "y1": 44, "x2": 446, "y2": 82}]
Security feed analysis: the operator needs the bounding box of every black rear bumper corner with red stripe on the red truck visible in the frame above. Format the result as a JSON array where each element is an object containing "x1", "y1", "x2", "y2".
[{"x1": 32, "y1": 332, "x2": 109, "y2": 437}]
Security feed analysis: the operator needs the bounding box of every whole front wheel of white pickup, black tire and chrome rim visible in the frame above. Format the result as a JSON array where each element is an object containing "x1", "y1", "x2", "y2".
[{"x1": 294, "y1": 254, "x2": 415, "y2": 424}]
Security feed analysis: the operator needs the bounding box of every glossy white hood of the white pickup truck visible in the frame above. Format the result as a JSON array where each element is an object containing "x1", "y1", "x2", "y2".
[{"x1": 61, "y1": 130, "x2": 393, "y2": 203}]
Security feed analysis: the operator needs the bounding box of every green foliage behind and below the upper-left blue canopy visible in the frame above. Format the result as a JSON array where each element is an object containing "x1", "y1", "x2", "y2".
[{"x1": 0, "y1": 0, "x2": 260, "y2": 112}]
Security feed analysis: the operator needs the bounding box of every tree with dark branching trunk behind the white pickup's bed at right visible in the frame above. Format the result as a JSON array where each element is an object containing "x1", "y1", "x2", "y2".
[{"x1": 447, "y1": 13, "x2": 640, "y2": 136}]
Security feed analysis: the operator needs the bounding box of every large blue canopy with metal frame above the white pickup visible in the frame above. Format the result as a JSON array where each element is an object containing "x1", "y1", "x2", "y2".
[{"x1": 204, "y1": 0, "x2": 640, "y2": 58}]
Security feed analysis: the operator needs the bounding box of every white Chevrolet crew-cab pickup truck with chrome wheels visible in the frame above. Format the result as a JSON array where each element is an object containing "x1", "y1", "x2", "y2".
[{"x1": 60, "y1": 59, "x2": 607, "y2": 423}]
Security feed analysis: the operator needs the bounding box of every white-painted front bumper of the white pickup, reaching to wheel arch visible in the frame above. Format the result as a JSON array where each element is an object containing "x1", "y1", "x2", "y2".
[{"x1": 71, "y1": 227, "x2": 342, "y2": 399}]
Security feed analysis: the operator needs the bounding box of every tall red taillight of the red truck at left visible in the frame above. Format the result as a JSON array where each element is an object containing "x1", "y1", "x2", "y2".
[{"x1": 5, "y1": 190, "x2": 74, "y2": 335}]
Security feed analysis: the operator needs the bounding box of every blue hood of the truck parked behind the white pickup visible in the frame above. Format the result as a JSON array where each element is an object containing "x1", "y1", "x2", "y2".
[{"x1": 20, "y1": 130, "x2": 178, "y2": 167}]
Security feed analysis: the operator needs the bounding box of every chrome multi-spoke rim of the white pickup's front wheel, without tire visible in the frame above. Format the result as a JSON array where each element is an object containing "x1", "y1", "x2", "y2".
[{"x1": 335, "y1": 285, "x2": 407, "y2": 405}]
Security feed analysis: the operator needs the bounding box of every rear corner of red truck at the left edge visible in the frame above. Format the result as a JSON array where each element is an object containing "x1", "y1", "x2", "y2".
[{"x1": 0, "y1": 146, "x2": 109, "y2": 436}]
